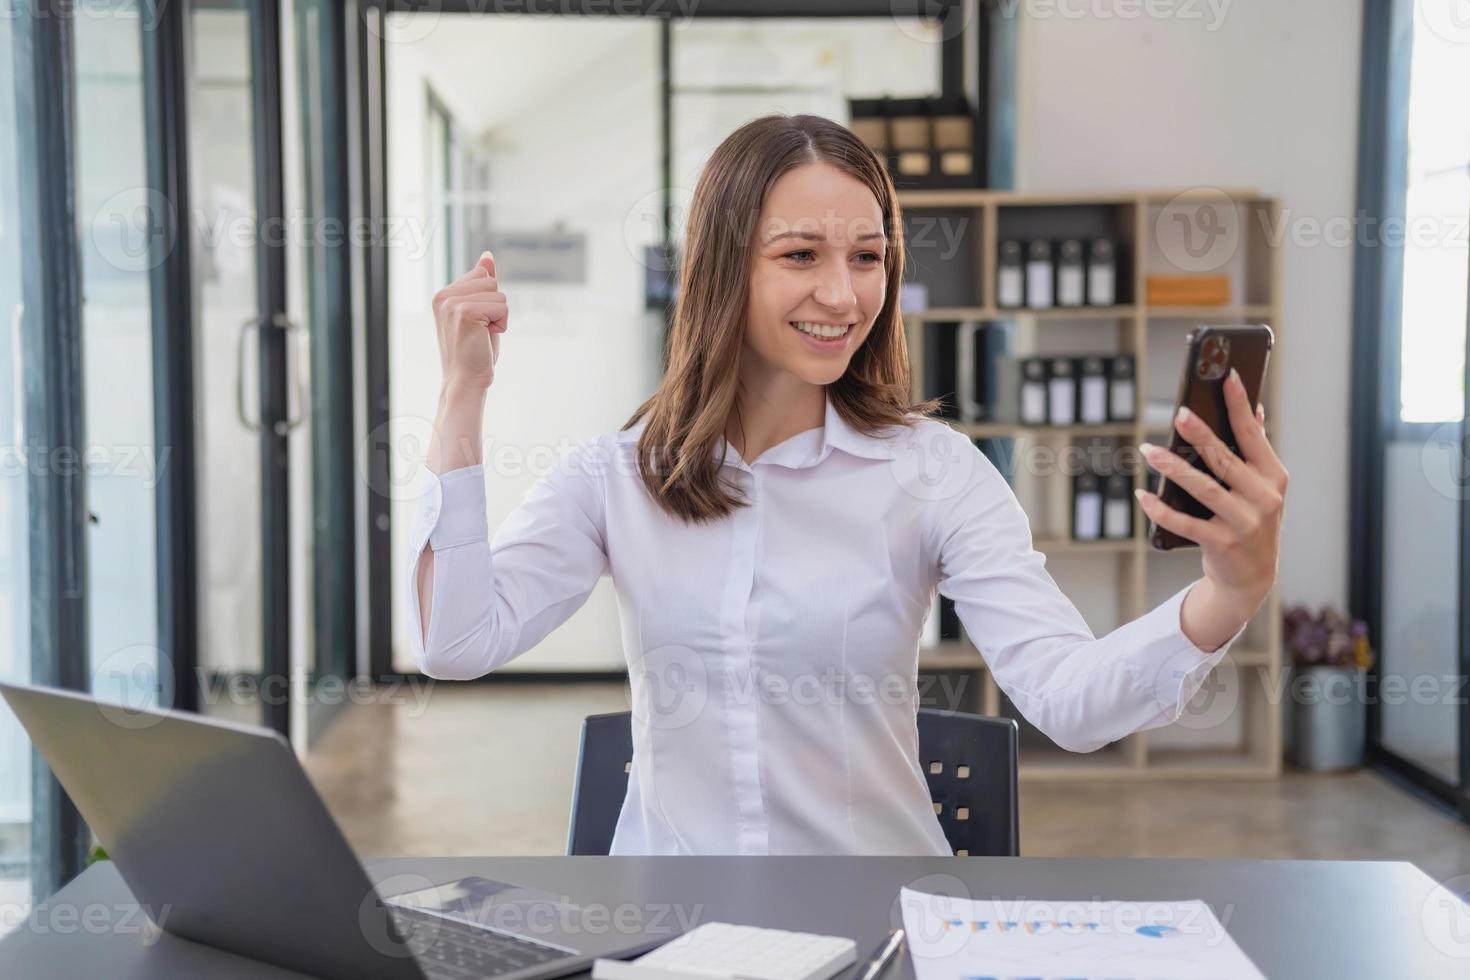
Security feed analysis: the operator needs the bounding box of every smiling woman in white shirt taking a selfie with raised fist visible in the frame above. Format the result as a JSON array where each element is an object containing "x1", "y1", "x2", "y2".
[{"x1": 410, "y1": 116, "x2": 1286, "y2": 854}]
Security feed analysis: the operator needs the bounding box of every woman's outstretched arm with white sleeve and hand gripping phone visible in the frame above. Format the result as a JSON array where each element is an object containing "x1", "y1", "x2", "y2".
[{"x1": 929, "y1": 364, "x2": 1286, "y2": 752}]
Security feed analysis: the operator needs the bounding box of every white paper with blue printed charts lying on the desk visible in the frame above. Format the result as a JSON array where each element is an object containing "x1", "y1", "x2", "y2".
[{"x1": 900, "y1": 887, "x2": 1264, "y2": 980}]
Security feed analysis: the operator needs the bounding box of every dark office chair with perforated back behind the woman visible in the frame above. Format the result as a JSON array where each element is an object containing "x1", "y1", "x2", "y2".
[{"x1": 566, "y1": 708, "x2": 1020, "y2": 857}]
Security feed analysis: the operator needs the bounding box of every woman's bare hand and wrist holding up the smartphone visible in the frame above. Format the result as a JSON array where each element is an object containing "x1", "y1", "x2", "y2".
[{"x1": 1133, "y1": 367, "x2": 1288, "y2": 651}]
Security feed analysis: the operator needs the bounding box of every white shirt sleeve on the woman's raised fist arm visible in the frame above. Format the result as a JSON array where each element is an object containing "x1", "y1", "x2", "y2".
[{"x1": 407, "y1": 439, "x2": 609, "y2": 680}]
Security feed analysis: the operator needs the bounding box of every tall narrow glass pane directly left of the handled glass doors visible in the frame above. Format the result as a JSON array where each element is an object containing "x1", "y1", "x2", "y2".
[{"x1": 72, "y1": 0, "x2": 162, "y2": 719}]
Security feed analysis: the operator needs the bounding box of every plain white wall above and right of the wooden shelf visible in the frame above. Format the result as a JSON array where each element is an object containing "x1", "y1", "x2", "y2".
[{"x1": 1016, "y1": 0, "x2": 1361, "y2": 605}]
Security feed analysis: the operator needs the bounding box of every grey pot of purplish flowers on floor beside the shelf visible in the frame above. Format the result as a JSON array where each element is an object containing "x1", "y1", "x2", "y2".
[{"x1": 1282, "y1": 605, "x2": 1373, "y2": 773}]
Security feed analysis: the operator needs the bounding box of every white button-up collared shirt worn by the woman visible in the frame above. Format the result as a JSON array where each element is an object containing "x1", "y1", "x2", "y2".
[{"x1": 407, "y1": 401, "x2": 1244, "y2": 854}]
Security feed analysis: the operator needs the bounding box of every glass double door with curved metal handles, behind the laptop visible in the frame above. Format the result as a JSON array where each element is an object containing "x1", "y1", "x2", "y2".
[{"x1": 188, "y1": 0, "x2": 356, "y2": 751}]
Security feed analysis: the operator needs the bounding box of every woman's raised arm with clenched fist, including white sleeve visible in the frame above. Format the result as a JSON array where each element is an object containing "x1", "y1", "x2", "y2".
[{"x1": 409, "y1": 253, "x2": 607, "y2": 680}]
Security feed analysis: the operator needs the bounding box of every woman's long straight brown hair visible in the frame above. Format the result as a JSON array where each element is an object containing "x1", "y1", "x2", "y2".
[{"x1": 623, "y1": 115, "x2": 939, "y2": 523}]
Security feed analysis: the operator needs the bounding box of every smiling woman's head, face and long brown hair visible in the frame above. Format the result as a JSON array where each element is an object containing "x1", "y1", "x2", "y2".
[{"x1": 625, "y1": 116, "x2": 938, "y2": 520}]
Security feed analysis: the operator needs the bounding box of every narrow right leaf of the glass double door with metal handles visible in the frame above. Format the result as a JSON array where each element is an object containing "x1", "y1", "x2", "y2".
[{"x1": 281, "y1": 0, "x2": 357, "y2": 746}]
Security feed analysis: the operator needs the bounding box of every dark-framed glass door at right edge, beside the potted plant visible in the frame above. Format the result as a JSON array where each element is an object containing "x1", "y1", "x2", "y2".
[{"x1": 1355, "y1": 4, "x2": 1470, "y2": 821}]
